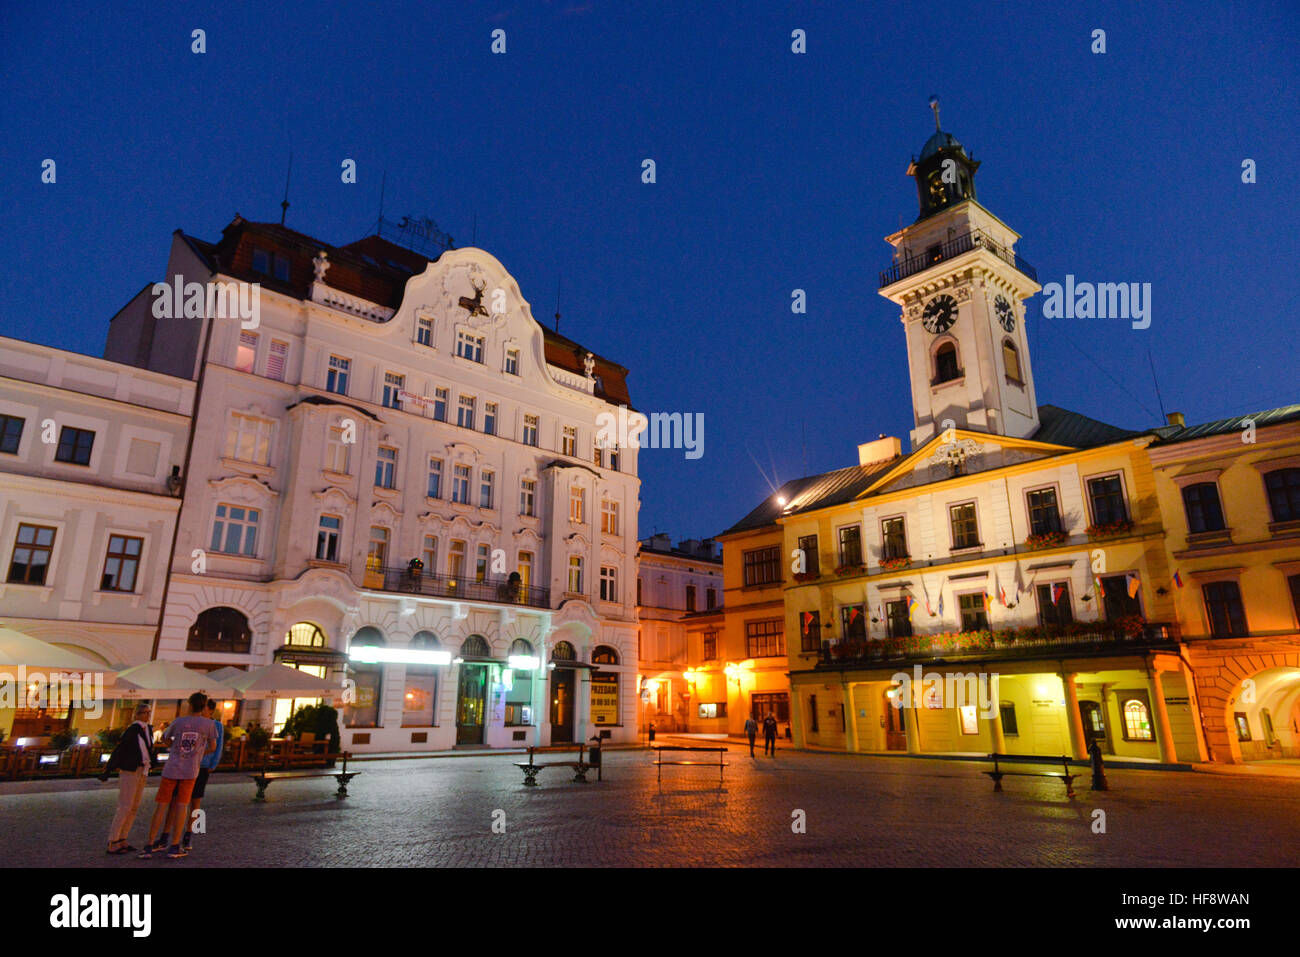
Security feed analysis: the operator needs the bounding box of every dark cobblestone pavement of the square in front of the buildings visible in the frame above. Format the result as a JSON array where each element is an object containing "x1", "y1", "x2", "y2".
[{"x1": 0, "y1": 746, "x2": 1300, "y2": 867}]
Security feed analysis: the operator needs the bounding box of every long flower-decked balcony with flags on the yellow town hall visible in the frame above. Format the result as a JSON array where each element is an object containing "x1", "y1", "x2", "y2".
[{"x1": 816, "y1": 618, "x2": 1178, "y2": 670}]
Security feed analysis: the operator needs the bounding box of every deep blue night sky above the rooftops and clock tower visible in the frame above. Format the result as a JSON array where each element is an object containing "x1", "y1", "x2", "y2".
[{"x1": 0, "y1": 0, "x2": 1300, "y2": 538}]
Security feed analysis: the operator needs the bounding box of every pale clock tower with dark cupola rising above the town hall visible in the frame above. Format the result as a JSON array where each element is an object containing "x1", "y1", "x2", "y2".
[{"x1": 880, "y1": 99, "x2": 1041, "y2": 449}]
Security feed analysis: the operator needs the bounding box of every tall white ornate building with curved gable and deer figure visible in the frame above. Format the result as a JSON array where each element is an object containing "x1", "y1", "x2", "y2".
[{"x1": 107, "y1": 216, "x2": 638, "y2": 752}]
